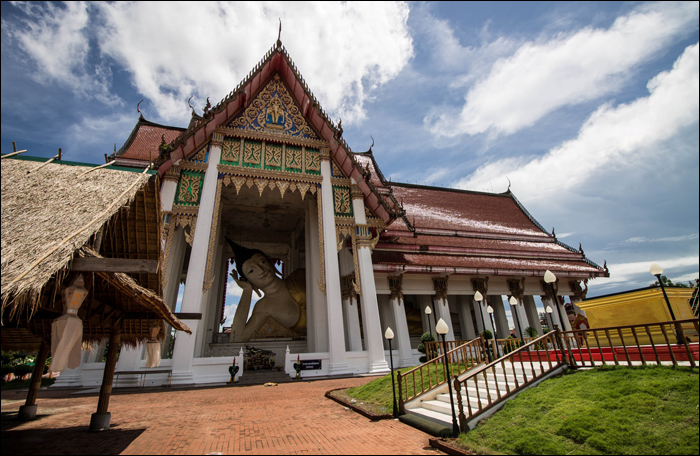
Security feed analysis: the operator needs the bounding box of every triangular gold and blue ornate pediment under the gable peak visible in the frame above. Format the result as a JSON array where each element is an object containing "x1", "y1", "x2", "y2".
[{"x1": 226, "y1": 74, "x2": 319, "y2": 140}]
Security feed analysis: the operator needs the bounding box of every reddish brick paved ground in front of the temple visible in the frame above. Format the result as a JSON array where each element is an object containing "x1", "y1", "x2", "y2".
[{"x1": 1, "y1": 378, "x2": 438, "y2": 454}]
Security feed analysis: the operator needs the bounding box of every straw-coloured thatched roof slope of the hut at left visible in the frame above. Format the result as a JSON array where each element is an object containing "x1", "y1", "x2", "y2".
[{"x1": 1, "y1": 158, "x2": 151, "y2": 318}]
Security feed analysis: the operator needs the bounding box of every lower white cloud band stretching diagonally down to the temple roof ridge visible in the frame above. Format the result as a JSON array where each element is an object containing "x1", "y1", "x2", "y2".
[{"x1": 456, "y1": 44, "x2": 699, "y2": 201}]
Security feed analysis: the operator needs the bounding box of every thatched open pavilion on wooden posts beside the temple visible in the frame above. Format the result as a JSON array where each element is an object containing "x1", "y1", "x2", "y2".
[{"x1": 0, "y1": 157, "x2": 190, "y2": 430}]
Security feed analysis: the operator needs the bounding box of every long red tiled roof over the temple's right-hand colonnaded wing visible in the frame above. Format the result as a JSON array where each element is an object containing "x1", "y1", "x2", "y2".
[{"x1": 372, "y1": 182, "x2": 608, "y2": 278}]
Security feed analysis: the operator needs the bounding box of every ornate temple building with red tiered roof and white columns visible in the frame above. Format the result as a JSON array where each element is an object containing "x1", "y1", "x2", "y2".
[{"x1": 57, "y1": 40, "x2": 608, "y2": 384}]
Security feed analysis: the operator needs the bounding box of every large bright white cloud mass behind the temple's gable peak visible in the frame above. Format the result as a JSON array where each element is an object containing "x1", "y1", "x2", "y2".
[{"x1": 8, "y1": 2, "x2": 413, "y2": 123}]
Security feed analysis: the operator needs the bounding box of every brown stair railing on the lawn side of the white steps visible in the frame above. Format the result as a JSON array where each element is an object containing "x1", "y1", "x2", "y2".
[{"x1": 453, "y1": 330, "x2": 565, "y2": 432}]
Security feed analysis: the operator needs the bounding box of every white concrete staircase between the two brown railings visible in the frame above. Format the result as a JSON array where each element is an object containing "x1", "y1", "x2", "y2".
[{"x1": 406, "y1": 361, "x2": 558, "y2": 428}]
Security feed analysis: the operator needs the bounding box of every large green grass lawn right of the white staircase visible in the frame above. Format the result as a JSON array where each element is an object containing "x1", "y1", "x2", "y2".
[{"x1": 459, "y1": 367, "x2": 700, "y2": 455}]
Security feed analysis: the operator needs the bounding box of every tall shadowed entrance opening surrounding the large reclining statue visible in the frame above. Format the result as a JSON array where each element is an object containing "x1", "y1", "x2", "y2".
[{"x1": 202, "y1": 180, "x2": 318, "y2": 369}]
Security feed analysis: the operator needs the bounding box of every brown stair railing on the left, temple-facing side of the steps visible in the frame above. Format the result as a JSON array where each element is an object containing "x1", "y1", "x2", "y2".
[{"x1": 396, "y1": 338, "x2": 488, "y2": 415}]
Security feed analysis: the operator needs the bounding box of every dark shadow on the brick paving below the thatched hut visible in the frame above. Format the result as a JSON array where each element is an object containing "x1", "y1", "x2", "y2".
[{"x1": 0, "y1": 412, "x2": 145, "y2": 455}]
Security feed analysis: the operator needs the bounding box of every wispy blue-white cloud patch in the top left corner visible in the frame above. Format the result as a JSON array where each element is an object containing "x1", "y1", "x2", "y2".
[{"x1": 2, "y1": 2, "x2": 121, "y2": 104}]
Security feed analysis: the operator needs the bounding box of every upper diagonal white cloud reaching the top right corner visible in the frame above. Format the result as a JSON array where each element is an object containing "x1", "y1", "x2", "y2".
[{"x1": 425, "y1": 2, "x2": 698, "y2": 137}]
